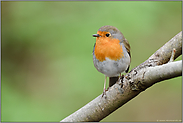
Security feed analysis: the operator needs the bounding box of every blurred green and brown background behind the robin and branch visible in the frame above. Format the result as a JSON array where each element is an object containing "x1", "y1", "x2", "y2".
[{"x1": 1, "y1": 1, "x2": 182, "y2": 122}]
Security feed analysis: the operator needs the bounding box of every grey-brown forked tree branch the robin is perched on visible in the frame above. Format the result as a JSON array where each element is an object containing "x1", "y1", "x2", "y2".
[{"x1": 61, "y1": 31, "x2": 182, "y2": 122}]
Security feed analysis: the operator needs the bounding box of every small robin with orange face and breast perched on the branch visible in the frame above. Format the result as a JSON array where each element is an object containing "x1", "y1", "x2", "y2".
[{"x1": 93, "y1": 25, "x2": 131, "y2": 97}]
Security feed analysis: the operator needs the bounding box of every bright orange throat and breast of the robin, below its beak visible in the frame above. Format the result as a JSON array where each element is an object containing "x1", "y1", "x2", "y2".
[{"x1": 94, "y1": 37, "x2": 124, "y2": 62}]
